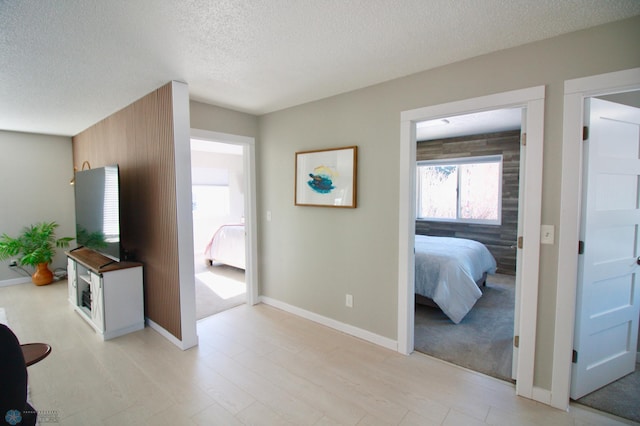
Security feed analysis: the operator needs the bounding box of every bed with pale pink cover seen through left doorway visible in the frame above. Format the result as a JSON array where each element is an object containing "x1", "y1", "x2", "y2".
[{"x1": 204, "y1": 225, "x2": 245, "y2": 269}]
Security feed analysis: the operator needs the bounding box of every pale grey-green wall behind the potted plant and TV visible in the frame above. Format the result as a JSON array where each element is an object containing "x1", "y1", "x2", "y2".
[{"x1": 0, "y1": 130, "x2": 75, "y2": 286}]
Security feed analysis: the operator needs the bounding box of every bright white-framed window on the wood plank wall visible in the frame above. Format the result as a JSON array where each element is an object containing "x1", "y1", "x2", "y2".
[{"x1": 416, "y1": 155, "x2": 502, "y2": 225}]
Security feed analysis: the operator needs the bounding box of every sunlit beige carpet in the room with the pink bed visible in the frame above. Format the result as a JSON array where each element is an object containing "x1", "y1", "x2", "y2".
[{"x1": 195, "y1": 262, "x2": 247, "y2": 319}]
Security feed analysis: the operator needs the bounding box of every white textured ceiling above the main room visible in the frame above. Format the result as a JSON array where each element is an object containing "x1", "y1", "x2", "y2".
[{"x1": 0, "y1": 0, "x2": 640, "y2": 135}]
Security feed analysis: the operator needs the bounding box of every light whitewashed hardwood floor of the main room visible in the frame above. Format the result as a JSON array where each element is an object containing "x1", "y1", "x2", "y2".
[{"x1": 0, "y1": 281, "x2": 629, "y2": 426}]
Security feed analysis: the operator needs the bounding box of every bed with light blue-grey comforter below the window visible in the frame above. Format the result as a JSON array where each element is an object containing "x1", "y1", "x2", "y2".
[{"x1": 415, "y1": 235, "x2": 496, "y2": 324}]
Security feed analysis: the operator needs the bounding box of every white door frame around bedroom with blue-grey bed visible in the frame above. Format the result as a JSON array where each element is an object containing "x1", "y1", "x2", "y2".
[{"x1": 398, "y1": 86, "x2": 548, "y2": 403}]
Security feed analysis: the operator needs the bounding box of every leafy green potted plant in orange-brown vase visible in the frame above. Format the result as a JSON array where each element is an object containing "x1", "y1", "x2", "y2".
[{"x1": 0, "y1": 222, "x2": 73, "y2": 285}]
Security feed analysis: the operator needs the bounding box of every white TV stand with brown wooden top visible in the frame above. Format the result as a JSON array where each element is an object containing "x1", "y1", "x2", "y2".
[{"x1": 66, "y1": 247, "x2": 144, "y2": 340}]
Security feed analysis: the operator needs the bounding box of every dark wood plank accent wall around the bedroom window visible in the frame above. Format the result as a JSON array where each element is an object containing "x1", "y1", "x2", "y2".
[{"x1": 416, "y1": 130, "x2": 520, "y2": 275}]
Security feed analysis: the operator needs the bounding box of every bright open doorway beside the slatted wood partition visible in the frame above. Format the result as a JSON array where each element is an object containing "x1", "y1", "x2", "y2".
[{"x1": 191, "y1": 132, "x2": 253, "y2": 320}]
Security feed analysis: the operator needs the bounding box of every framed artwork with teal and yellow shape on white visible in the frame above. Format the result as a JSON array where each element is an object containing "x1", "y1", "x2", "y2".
[{"x1": 295, "y1": 146, "x2": 358, "y2": 209}]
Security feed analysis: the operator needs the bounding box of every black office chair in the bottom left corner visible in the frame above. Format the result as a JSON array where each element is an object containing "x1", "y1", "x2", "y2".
[{"x1": 0, "y1": 324, "x2": 38, "y2": 426}]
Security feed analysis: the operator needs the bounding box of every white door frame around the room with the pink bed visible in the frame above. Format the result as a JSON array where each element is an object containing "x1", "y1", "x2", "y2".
[{"x1": 191, "y1": 129, "x2": 258, "y2": 305}]
